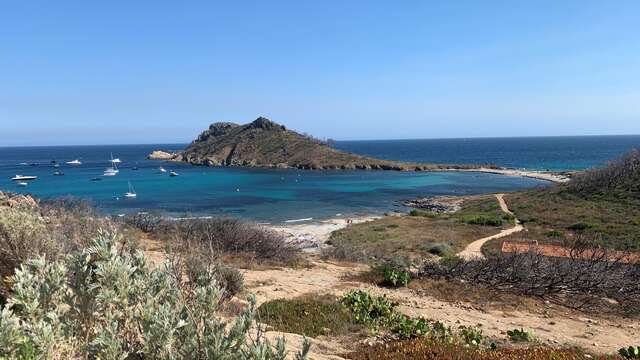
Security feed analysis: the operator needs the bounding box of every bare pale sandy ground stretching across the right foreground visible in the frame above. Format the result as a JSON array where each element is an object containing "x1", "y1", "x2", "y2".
[{"x1": 244, "y1": 260, "x2": 640, "y2": 359}]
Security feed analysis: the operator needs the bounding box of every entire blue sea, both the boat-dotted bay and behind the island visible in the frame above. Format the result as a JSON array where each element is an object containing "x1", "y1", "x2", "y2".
[{"x1": 0, "y1": 136, "x2": 640, "y2": 224}]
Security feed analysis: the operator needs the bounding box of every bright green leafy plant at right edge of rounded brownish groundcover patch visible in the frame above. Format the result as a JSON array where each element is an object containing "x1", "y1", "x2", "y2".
[{"x1": 342, "y1": 290, "x2": 396, "y2": 325}]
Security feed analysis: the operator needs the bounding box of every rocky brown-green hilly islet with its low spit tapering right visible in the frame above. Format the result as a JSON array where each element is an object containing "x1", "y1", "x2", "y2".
[{"x1": 148, "y1": 117, "x2": 568, "y2": 183}]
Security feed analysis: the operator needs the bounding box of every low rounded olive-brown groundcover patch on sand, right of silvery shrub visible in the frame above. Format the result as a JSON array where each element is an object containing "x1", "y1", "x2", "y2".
[{"x1": 257, "y1": 297, "x2": 360, "y2": 337}]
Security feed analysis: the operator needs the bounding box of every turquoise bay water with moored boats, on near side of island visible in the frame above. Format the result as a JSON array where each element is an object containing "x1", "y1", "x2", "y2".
[{"x1": 0, "y1": 145, "x2": 545, "y2": 223}]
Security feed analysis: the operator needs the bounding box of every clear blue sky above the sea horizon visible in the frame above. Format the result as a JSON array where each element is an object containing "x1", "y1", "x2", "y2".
[{"x1": 0, "y1": 0, "x2": 640, "y2": 146}]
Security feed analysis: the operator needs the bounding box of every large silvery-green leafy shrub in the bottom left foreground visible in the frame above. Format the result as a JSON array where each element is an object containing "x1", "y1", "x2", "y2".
[{"x1": 0, "y1": 233, "x2": 309, "y2": 359}]
